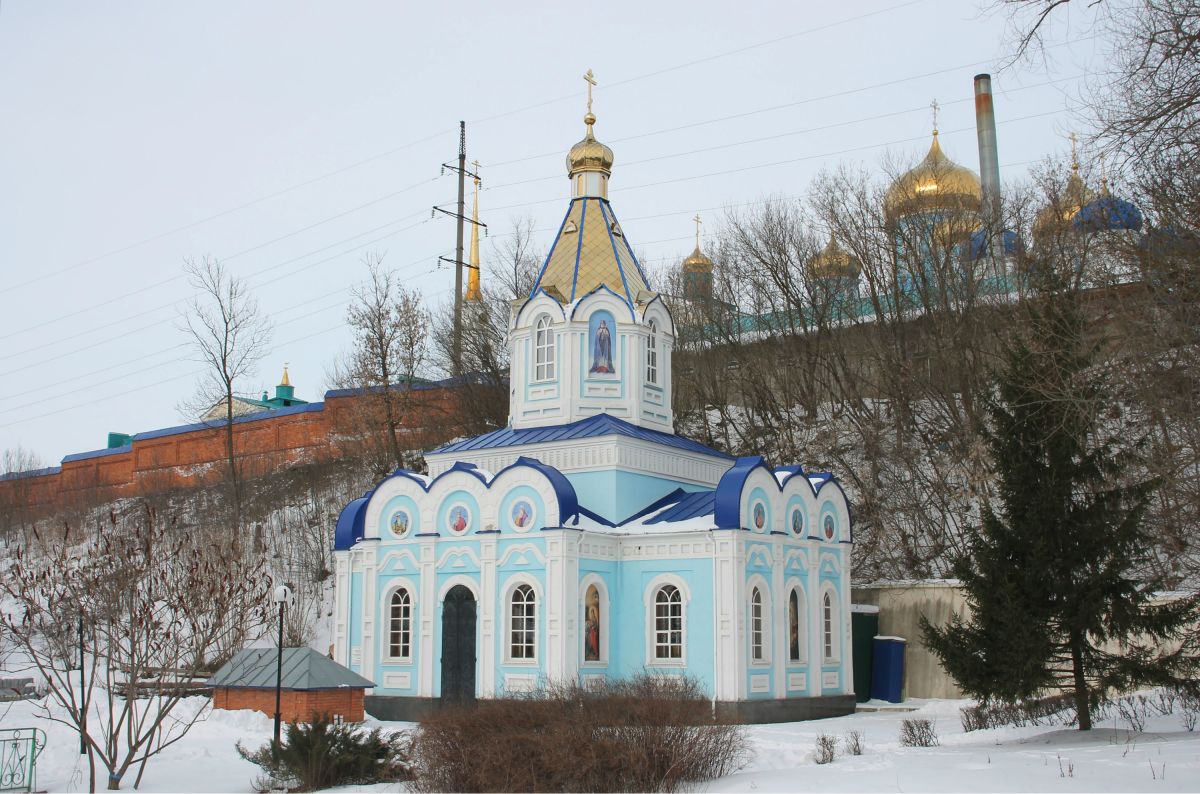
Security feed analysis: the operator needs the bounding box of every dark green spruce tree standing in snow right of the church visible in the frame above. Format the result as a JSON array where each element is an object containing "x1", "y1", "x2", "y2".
[{"x1": 923, "y1": 284, "x2": 1196, "y2": 730}]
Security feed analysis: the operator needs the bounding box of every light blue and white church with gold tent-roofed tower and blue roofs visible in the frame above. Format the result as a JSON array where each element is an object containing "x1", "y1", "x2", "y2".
[{"x1": 334, "y1": 85, "x2": 854, "y2": 722}]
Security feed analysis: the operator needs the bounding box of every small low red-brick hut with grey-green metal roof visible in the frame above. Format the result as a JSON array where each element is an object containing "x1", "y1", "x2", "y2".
[{"x1": 205, "y1": 648, "x2": 374, "y2": 722}]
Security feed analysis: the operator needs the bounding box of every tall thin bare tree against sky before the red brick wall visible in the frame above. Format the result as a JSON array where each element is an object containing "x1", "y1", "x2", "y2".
[{"x1": 182, "y1": 257, "x2": 271, "y2": 545}]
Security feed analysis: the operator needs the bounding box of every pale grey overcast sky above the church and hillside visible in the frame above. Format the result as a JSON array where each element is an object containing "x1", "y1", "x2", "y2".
[{"x1": 0, "y1": 0, "x2": 1103, "y2": 465}]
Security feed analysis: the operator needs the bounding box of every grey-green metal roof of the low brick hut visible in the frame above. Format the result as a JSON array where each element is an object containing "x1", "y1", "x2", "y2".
[{"x1": 204, "y1": 646, "x2": 374, "y2": 690}]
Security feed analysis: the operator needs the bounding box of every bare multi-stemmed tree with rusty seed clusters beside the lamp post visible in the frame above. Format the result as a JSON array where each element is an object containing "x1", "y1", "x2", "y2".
[{"x1": 0, "y1": 505, "x2": 270, "y2": 790}]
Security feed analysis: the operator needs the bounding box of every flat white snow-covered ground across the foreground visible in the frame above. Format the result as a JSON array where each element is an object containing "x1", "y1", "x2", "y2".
[{"x1": 9, "y1": 698, "x2": 1200, "y2": 793}]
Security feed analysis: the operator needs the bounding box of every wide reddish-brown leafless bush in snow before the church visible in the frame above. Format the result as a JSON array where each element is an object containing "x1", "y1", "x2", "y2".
[{"x1": 410, "y1": 674, "x2": 746, "y2": 792}]
